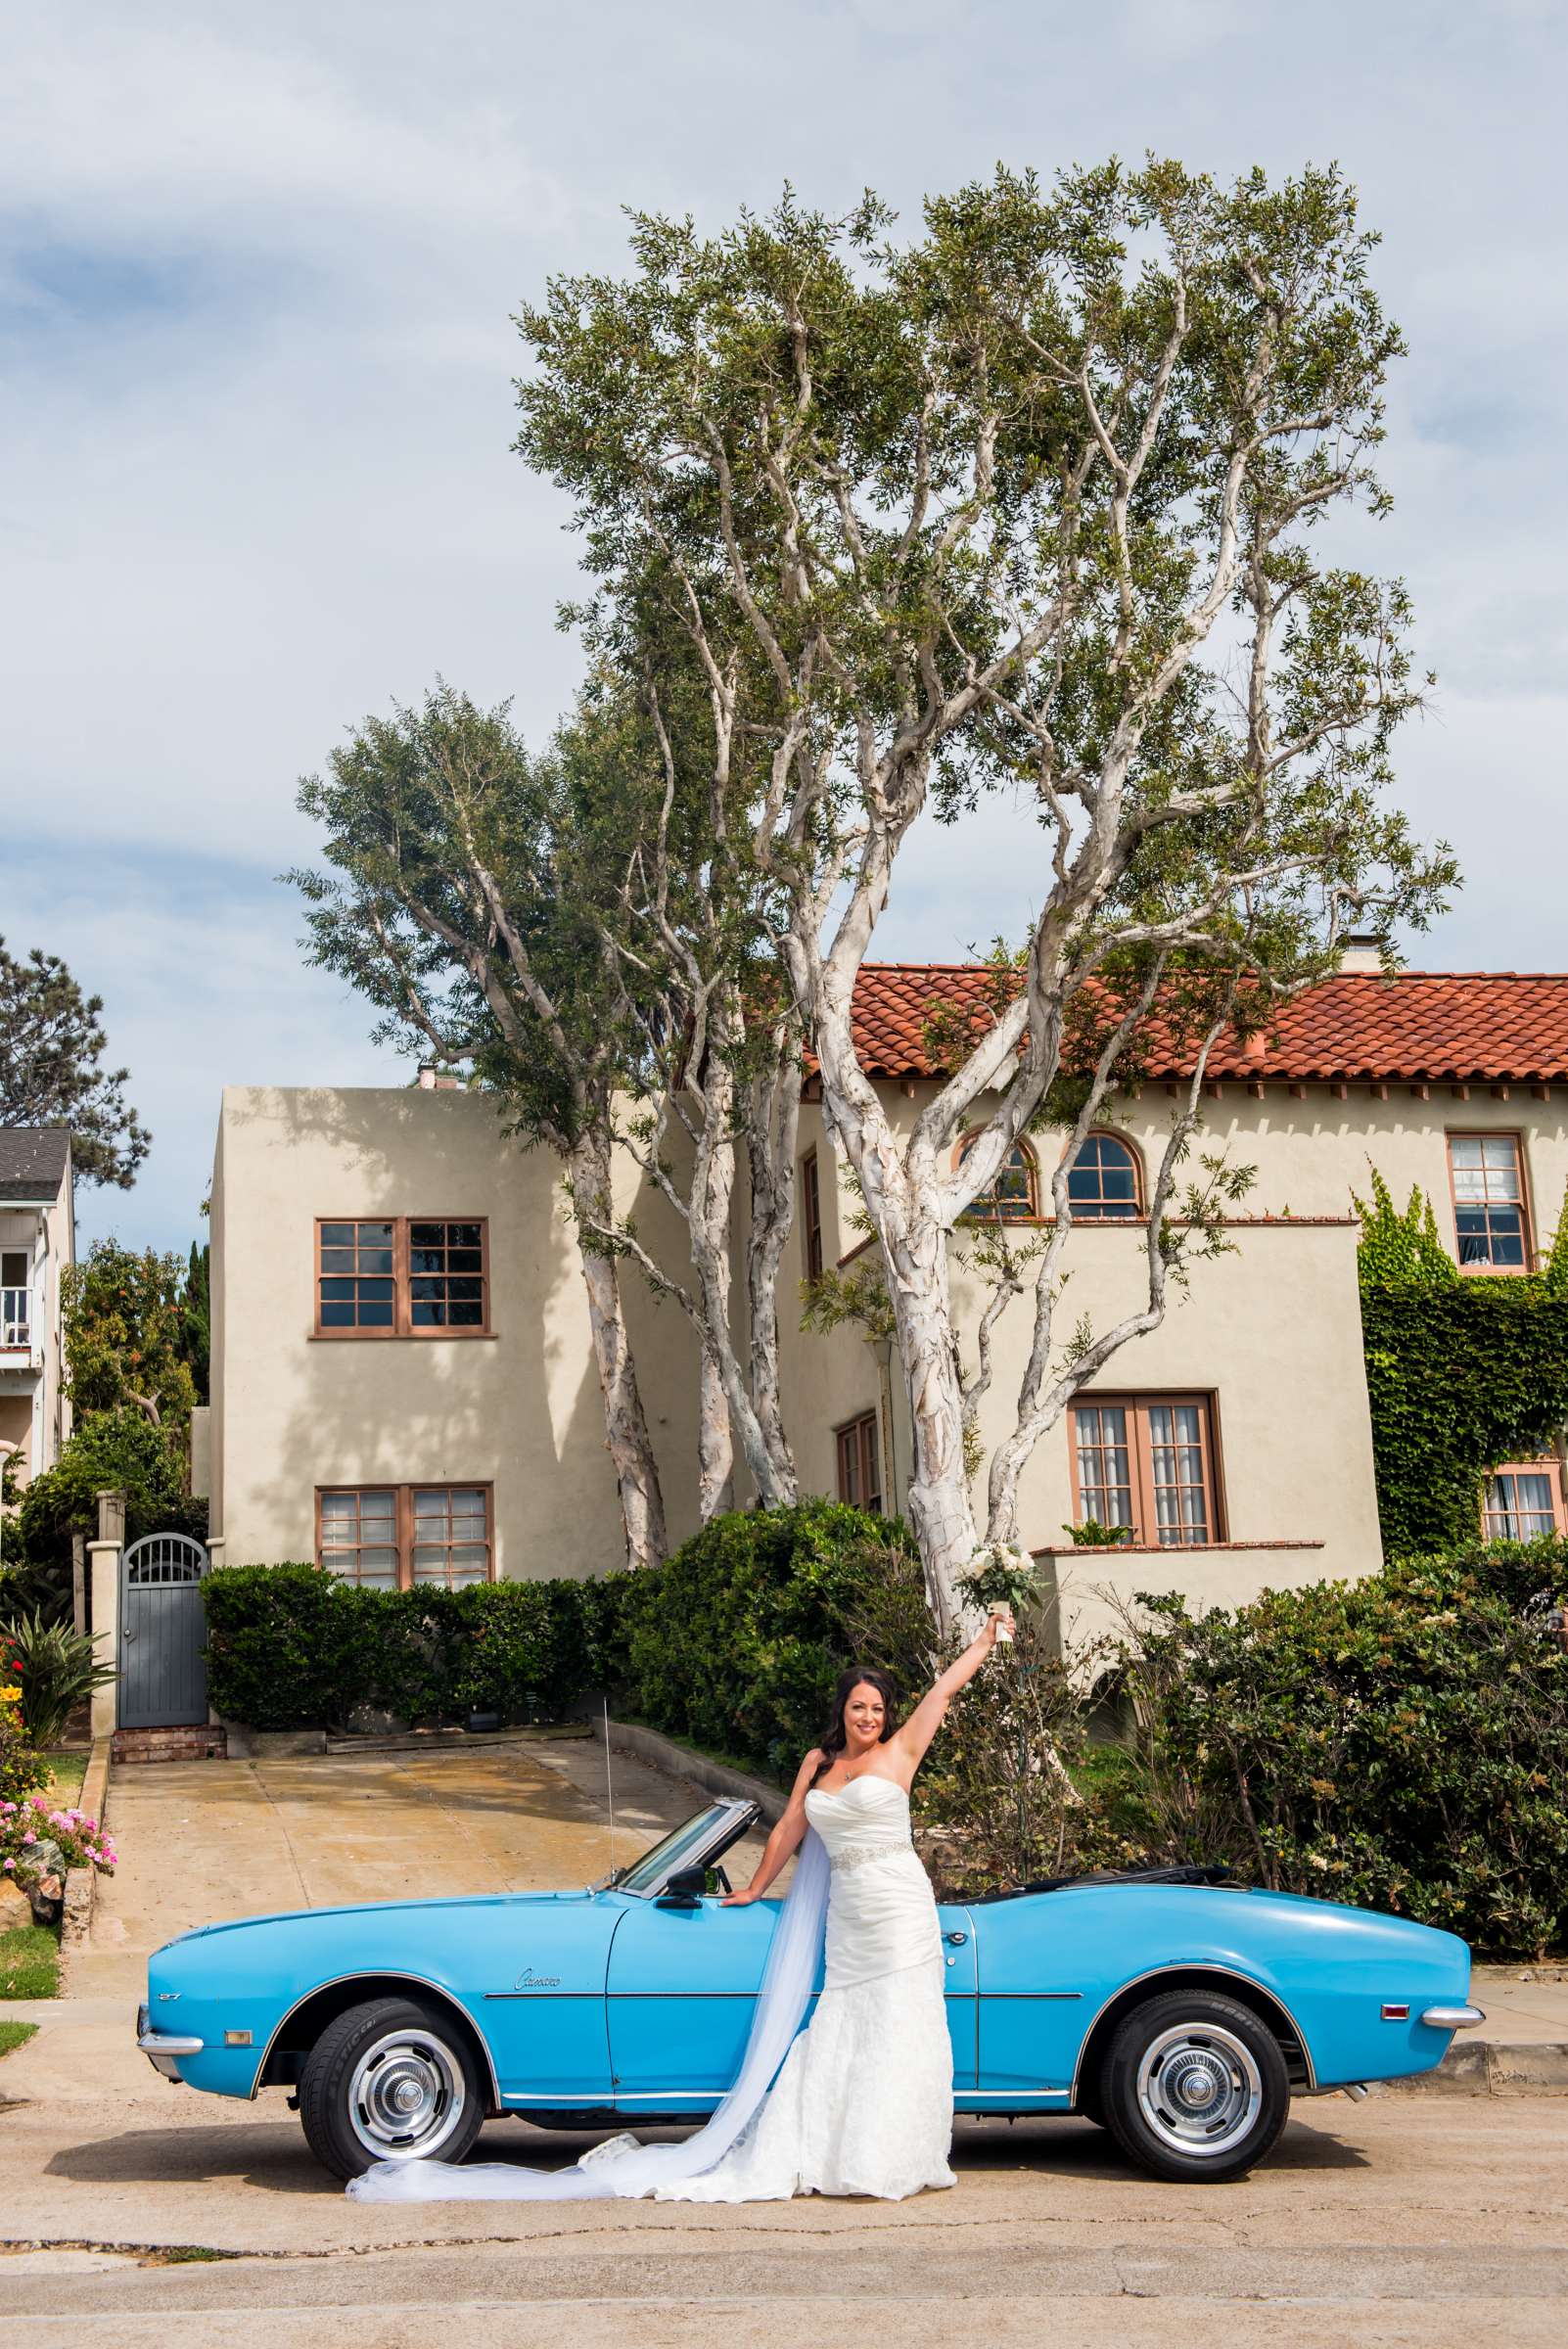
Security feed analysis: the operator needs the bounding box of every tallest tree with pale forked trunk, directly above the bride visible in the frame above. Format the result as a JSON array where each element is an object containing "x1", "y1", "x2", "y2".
[{"x1": 519, "y1": 162, "x2": 1451, "y2": 1621}]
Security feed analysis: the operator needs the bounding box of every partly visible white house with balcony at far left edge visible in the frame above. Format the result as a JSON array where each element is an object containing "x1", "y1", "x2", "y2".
[{"x1": 0, "y1": 1126, "x2": 75, "y2": 1485}]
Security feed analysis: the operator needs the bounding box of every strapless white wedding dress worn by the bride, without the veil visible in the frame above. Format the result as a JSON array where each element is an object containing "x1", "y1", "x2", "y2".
[{"x1": 655, "y1": 1775, "x2": 955, "y2": 2201}]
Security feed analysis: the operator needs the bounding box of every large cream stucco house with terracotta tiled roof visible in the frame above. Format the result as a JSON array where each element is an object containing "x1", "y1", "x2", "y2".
[{"x1": 211, "y1": 965, "x2": 1568, "y2": 1621}]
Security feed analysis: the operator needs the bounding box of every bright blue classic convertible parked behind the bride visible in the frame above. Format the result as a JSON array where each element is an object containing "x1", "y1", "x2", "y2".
[{"x1": 136, "y1": 1799, "x2": 1486, "y2": 2180}]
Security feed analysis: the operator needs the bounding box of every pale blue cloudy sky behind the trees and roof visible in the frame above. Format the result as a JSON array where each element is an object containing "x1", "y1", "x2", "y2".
[{"x1": 0, "y1": 0, "x2": 1568, "y2": 1247}]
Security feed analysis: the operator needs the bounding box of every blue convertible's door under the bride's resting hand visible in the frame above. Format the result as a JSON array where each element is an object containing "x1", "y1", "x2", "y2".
[{"x1": 608, "y1": 1898, "x2": 779, "y2": 2112}]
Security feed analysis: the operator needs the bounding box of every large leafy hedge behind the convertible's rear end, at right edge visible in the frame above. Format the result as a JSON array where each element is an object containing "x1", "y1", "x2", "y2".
[{"x1": 1107, "y1": 1541, "x2": 1568, "y2": 1959}]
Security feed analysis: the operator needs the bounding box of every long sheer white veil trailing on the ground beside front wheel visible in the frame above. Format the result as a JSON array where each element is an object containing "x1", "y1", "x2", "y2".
[{"x1": 347, "y1": 1827, "x2": 829, "y2": 2201}]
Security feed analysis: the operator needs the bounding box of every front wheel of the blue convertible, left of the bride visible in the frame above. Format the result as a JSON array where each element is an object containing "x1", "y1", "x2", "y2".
[{"x1": 300, "y1": 1999, "x2": 485, "y2": 2178}]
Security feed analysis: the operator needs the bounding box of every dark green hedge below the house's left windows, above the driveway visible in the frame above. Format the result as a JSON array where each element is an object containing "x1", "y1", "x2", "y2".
[{"x1": 202, "y1": 1501, "x2": 930, "y2": 1773}]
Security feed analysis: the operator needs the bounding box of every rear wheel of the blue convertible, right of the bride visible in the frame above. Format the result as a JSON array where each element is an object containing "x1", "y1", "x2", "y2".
[{"x1": 1101, "y1": 1990, "x2": 1291, "y2": 2185}]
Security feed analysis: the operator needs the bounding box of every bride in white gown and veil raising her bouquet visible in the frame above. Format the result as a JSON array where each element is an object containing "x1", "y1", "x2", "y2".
[{"x1": 347, "y1": 1614, "x2": 1012, "y2": 2201}]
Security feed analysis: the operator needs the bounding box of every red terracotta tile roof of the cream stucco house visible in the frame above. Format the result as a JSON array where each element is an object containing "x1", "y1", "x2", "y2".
[{"x1": 854, "y1": 963, "x2": 1568, "y2": 1082}]
